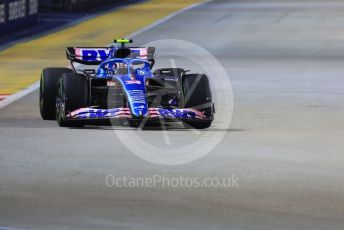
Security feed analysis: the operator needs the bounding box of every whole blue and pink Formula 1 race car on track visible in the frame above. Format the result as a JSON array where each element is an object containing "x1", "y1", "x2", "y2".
[{"x1": 39, "y1": 39, "x2": 214, "y2": 129}]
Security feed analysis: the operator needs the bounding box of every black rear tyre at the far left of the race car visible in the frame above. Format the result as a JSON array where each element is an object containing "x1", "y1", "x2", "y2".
[{"x1": 39, "y1": 68, "x2": 73, "y2": 120}]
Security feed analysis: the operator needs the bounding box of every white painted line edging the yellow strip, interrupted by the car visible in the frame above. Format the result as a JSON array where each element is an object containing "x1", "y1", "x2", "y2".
[{"x1": 0, "y1": 0, "x2": 212, "y2": 109}]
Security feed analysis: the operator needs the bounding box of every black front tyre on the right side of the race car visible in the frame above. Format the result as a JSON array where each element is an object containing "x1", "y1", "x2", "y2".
[{"x1": 182, "y1": 74, "x2": 214, "y2": 129}]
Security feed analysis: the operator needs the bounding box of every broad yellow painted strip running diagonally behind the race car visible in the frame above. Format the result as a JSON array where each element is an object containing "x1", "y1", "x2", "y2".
[{"x1": 0, "y1": 0, "x2": 201, "y2": 94}]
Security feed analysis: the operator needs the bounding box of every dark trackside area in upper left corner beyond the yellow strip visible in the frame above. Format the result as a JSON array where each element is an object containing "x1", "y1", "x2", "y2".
[{"x1": 0, "y1": 0, "x2": 142, "y2": 36}]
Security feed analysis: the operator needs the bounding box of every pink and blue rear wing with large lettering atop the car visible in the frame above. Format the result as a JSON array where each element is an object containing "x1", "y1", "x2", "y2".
[{"x1": 66, "y1": 47, "x2": 155, "y2": 65}]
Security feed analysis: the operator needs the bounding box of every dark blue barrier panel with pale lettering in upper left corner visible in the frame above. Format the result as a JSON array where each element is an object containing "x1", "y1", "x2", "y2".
[{"x1": 0, "y1": 0, "x2": 39, "y2": 34}]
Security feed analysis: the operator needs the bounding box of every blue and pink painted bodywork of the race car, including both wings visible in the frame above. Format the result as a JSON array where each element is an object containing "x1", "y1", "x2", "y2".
[{"x1": 66, "y1": 47, "x2": 207, "y2": 120}]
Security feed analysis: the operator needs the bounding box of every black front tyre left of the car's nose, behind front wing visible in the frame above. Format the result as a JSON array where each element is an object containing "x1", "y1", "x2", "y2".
[{"x1": 56, "y1": 73, "x2": 88, "y2": 127}]
